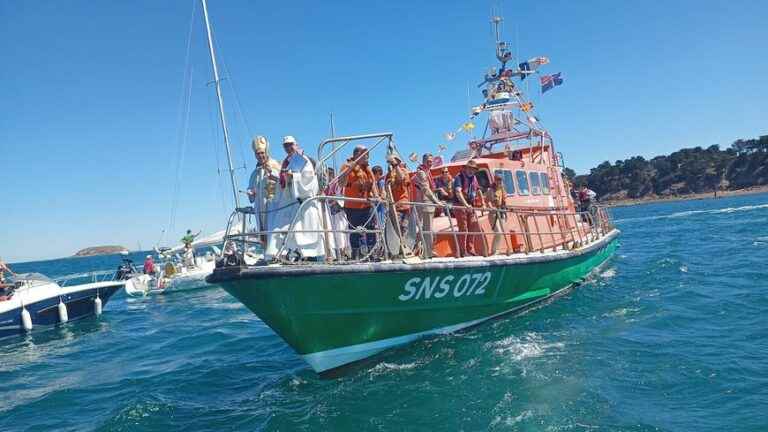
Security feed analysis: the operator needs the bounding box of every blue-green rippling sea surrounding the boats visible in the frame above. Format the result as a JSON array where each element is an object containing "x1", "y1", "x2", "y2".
[{"x1": 0, "y1": 194, "x2": 768, "y2": 431}]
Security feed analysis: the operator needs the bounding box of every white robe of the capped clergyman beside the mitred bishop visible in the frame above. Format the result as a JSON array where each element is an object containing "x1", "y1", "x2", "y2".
[{"x1": 265, "y1": 153, "x2": 332, "y2": 259}]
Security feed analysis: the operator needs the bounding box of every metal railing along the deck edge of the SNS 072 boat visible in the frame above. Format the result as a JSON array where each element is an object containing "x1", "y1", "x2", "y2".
[{"x1": 222, "y1": 195, "x2": 613, "y2": 264}]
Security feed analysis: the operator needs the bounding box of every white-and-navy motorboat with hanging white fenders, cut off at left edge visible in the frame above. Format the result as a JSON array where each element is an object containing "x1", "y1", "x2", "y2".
[{"x1": 0, "y1": 272, "x2": 126, "y2": 338}]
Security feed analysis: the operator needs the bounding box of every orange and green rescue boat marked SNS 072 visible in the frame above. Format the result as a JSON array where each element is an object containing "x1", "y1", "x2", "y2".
[{"x1": 202, "y1": 6, "x2": 620, "y2": 372}]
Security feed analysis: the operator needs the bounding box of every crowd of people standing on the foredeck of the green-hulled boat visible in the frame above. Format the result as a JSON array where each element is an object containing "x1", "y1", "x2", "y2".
[{"x1": 247, "y1": 136, "x2": 520, "y2": 261}]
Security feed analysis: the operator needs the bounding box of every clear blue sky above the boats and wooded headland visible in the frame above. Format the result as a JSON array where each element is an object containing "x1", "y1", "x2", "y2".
[{"x1": 0, "y1": 0, "x2": 768, "y2": 261}]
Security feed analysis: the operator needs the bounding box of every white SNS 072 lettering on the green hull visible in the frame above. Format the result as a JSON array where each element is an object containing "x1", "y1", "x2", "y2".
[{"x1": 397, "y1": 272, "x2": 492, "y2": 301}]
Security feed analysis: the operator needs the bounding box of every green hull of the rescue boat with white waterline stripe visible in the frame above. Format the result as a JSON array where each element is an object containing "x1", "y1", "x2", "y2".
[{"x1": 209, "y1": 230, "x2": 619, "y2": 372}]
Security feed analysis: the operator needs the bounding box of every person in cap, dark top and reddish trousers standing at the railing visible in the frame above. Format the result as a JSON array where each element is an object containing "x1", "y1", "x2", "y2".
[{"x1": 453, "y1": 159, "x2": 485, "y2": 257}]
